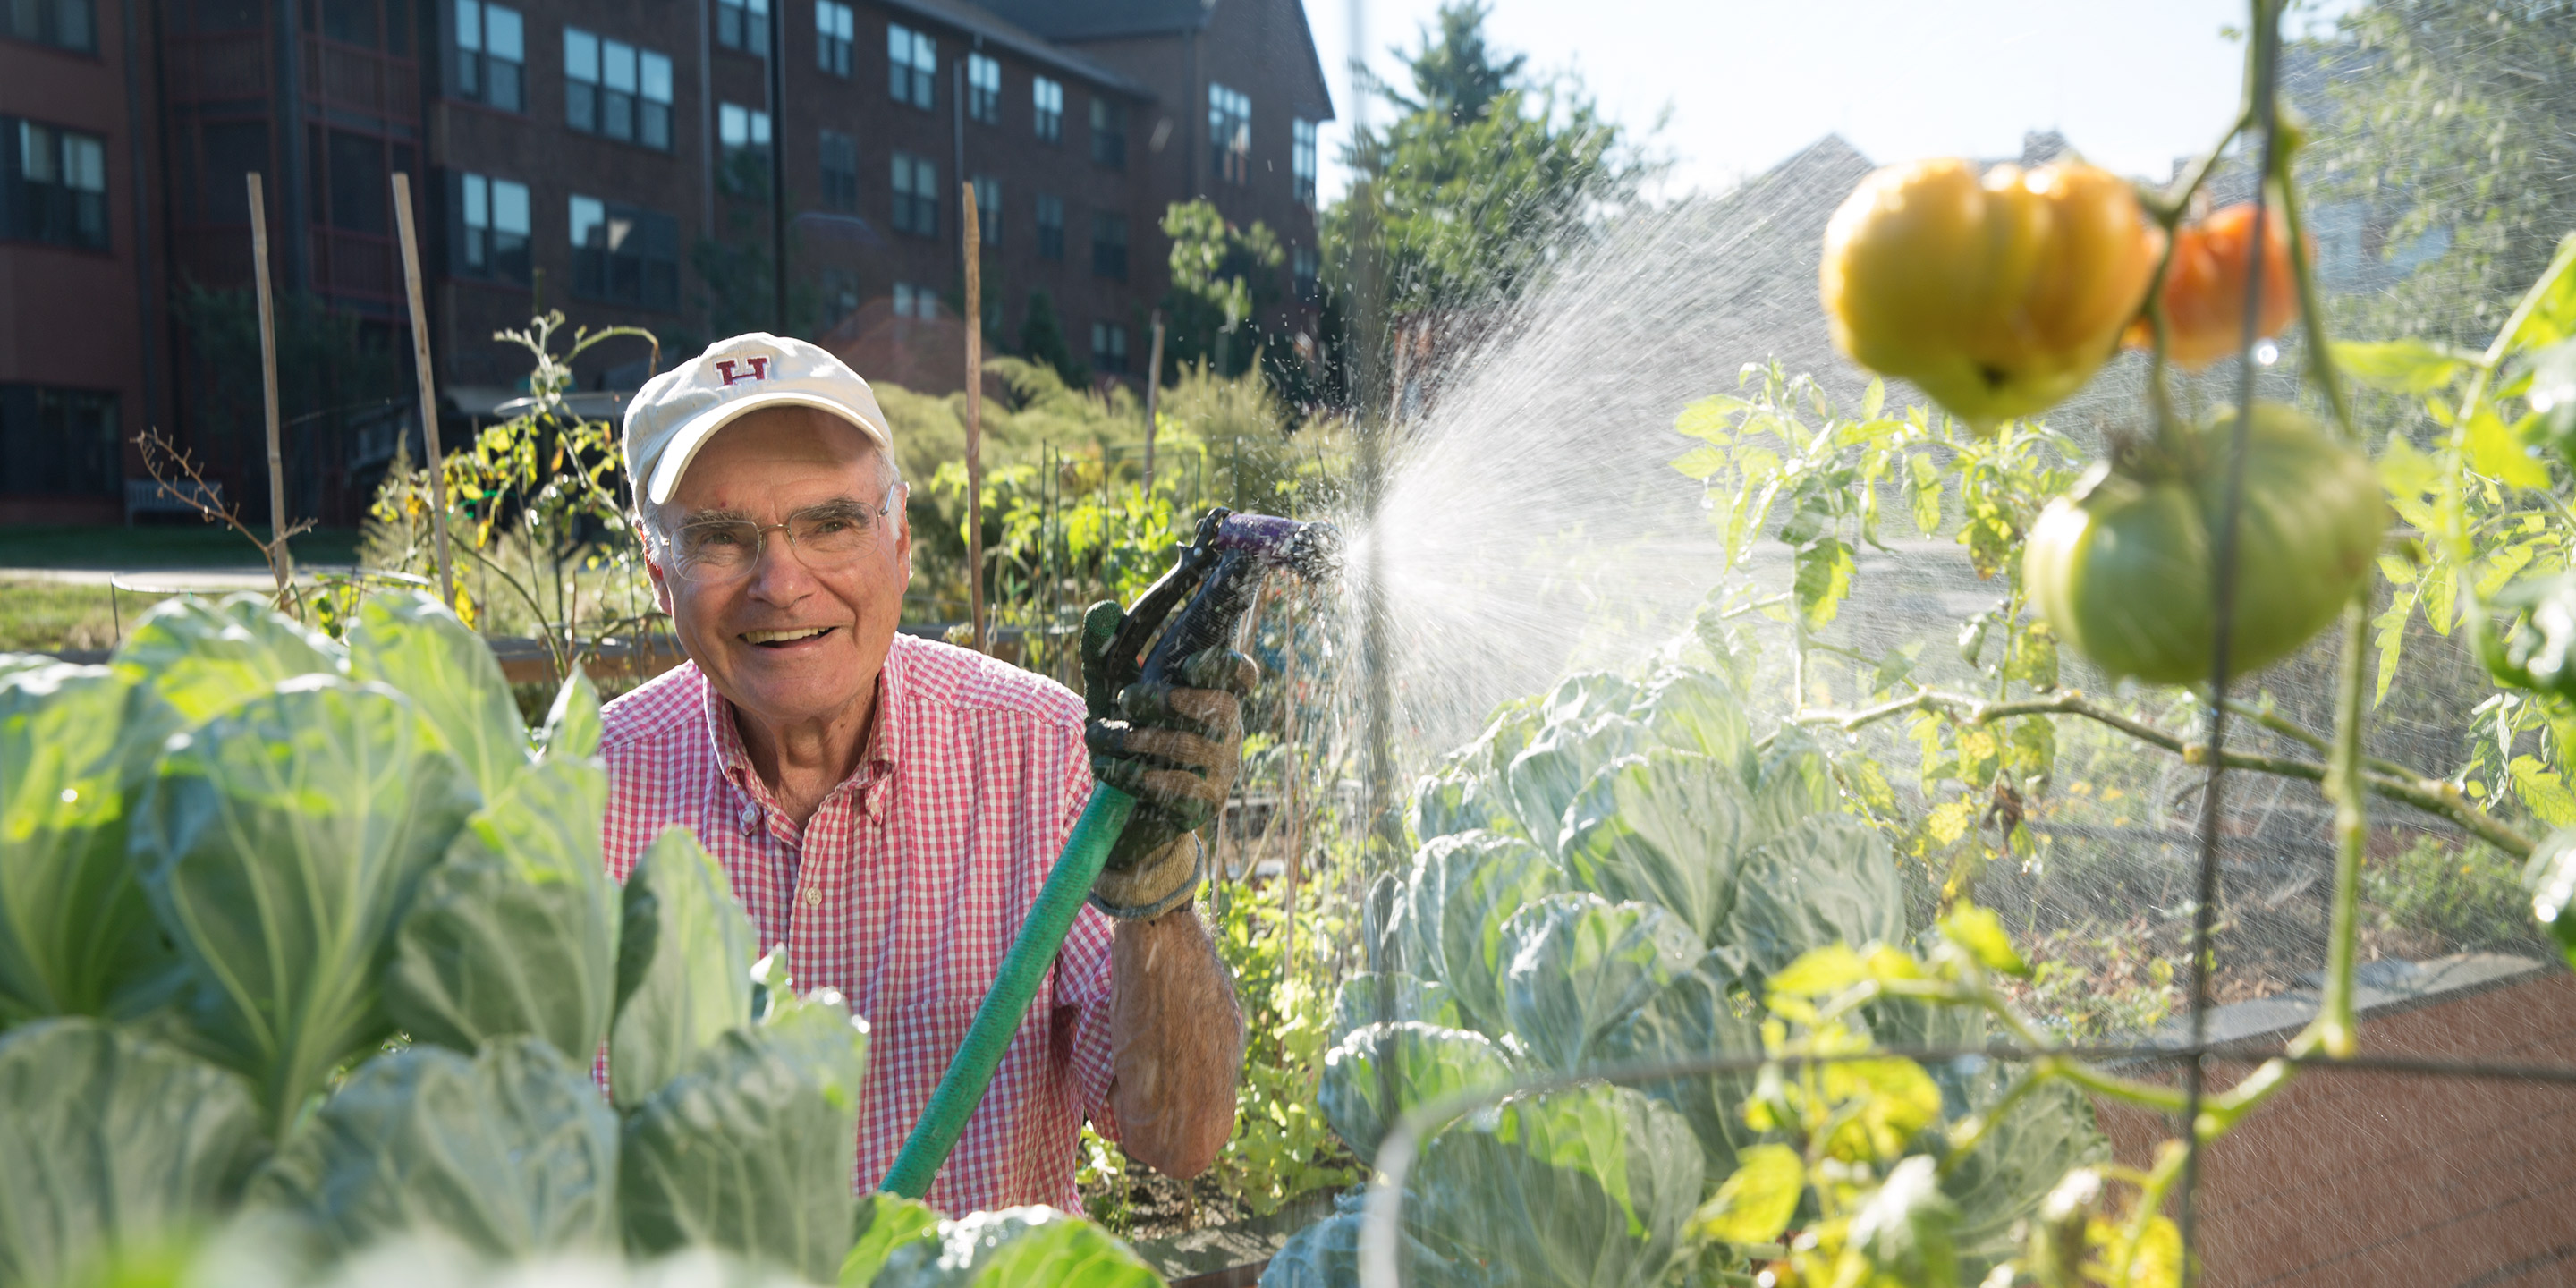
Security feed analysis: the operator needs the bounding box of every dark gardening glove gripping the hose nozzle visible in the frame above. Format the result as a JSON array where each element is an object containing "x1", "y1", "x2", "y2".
[{"x1": 1082, "y1": 600, "x2": 1259, "y2": 917}]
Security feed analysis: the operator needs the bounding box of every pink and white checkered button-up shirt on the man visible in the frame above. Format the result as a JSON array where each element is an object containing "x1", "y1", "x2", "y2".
[{"x1": 600, "y1": 636, "x2": 1118, "y2": 1213}]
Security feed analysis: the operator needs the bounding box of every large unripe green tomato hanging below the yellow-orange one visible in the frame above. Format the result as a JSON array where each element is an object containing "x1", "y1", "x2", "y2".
[{"x1": 2022, "y1": 404, "x2": 2388, "y2": 685}]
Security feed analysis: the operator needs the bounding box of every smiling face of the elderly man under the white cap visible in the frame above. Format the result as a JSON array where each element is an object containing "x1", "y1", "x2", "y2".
[{"x1": 649, "y1": 407, "x2": 912, "y2": 734}]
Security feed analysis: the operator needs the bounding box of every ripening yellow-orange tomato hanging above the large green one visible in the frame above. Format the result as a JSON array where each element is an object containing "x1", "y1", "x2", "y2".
[{"x1": 1821, "y1": 157, "x2": 2164, "y2": 433}]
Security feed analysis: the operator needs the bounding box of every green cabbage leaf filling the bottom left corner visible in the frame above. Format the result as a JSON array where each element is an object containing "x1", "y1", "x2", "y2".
[{"x1": 0, "y1": 1020, "x2": 260, "y2": 1285}]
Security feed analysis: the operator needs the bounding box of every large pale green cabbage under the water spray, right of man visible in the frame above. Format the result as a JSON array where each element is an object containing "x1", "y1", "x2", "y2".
[{"x1": 1262, "y1": 657, "x2": 2105, "y2": 1288}]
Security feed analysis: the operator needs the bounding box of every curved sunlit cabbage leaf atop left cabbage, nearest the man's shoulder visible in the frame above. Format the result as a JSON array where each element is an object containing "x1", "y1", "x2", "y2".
[{"x1": 348, "y1": 590, "x2": 528, "y2": 801}]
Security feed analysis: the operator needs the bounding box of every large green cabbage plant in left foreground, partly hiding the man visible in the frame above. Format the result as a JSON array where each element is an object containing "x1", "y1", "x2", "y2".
[{"x1": 0, "y1": 595, "x2": 1154, "y2": 1285}]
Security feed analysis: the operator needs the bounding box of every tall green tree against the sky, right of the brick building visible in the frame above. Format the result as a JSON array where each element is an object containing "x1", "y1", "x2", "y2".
[{"x1": 1324, "y1": 0, "x2": 1654, "y2": 314}]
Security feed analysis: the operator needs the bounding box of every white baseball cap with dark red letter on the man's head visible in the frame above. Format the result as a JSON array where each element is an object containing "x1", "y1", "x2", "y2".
[{"x1": 623, "y1": 330, "x2": 894, "y2": 504}]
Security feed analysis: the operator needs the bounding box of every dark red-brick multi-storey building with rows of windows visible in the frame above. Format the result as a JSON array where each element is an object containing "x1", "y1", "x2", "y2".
[{"x1": 0, "y1": 0, "x2": 1332, "y2": 523}]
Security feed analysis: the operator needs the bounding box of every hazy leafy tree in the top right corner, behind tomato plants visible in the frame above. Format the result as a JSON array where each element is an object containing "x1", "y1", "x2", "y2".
[{"x1": 2308, "y1": 0, "x2": 2576, "y2": 343}]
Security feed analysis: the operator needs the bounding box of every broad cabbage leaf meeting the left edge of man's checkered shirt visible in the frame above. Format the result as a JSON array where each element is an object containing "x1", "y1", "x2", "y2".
[{"x1": 384, "y1": 758, "x2": 618, "y2": 1059}]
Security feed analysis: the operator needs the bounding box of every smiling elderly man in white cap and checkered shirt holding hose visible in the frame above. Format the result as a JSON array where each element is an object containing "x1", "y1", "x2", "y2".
[{"x1": 600, "y1": 333, "x2": 1252, "y2": 1213}]
